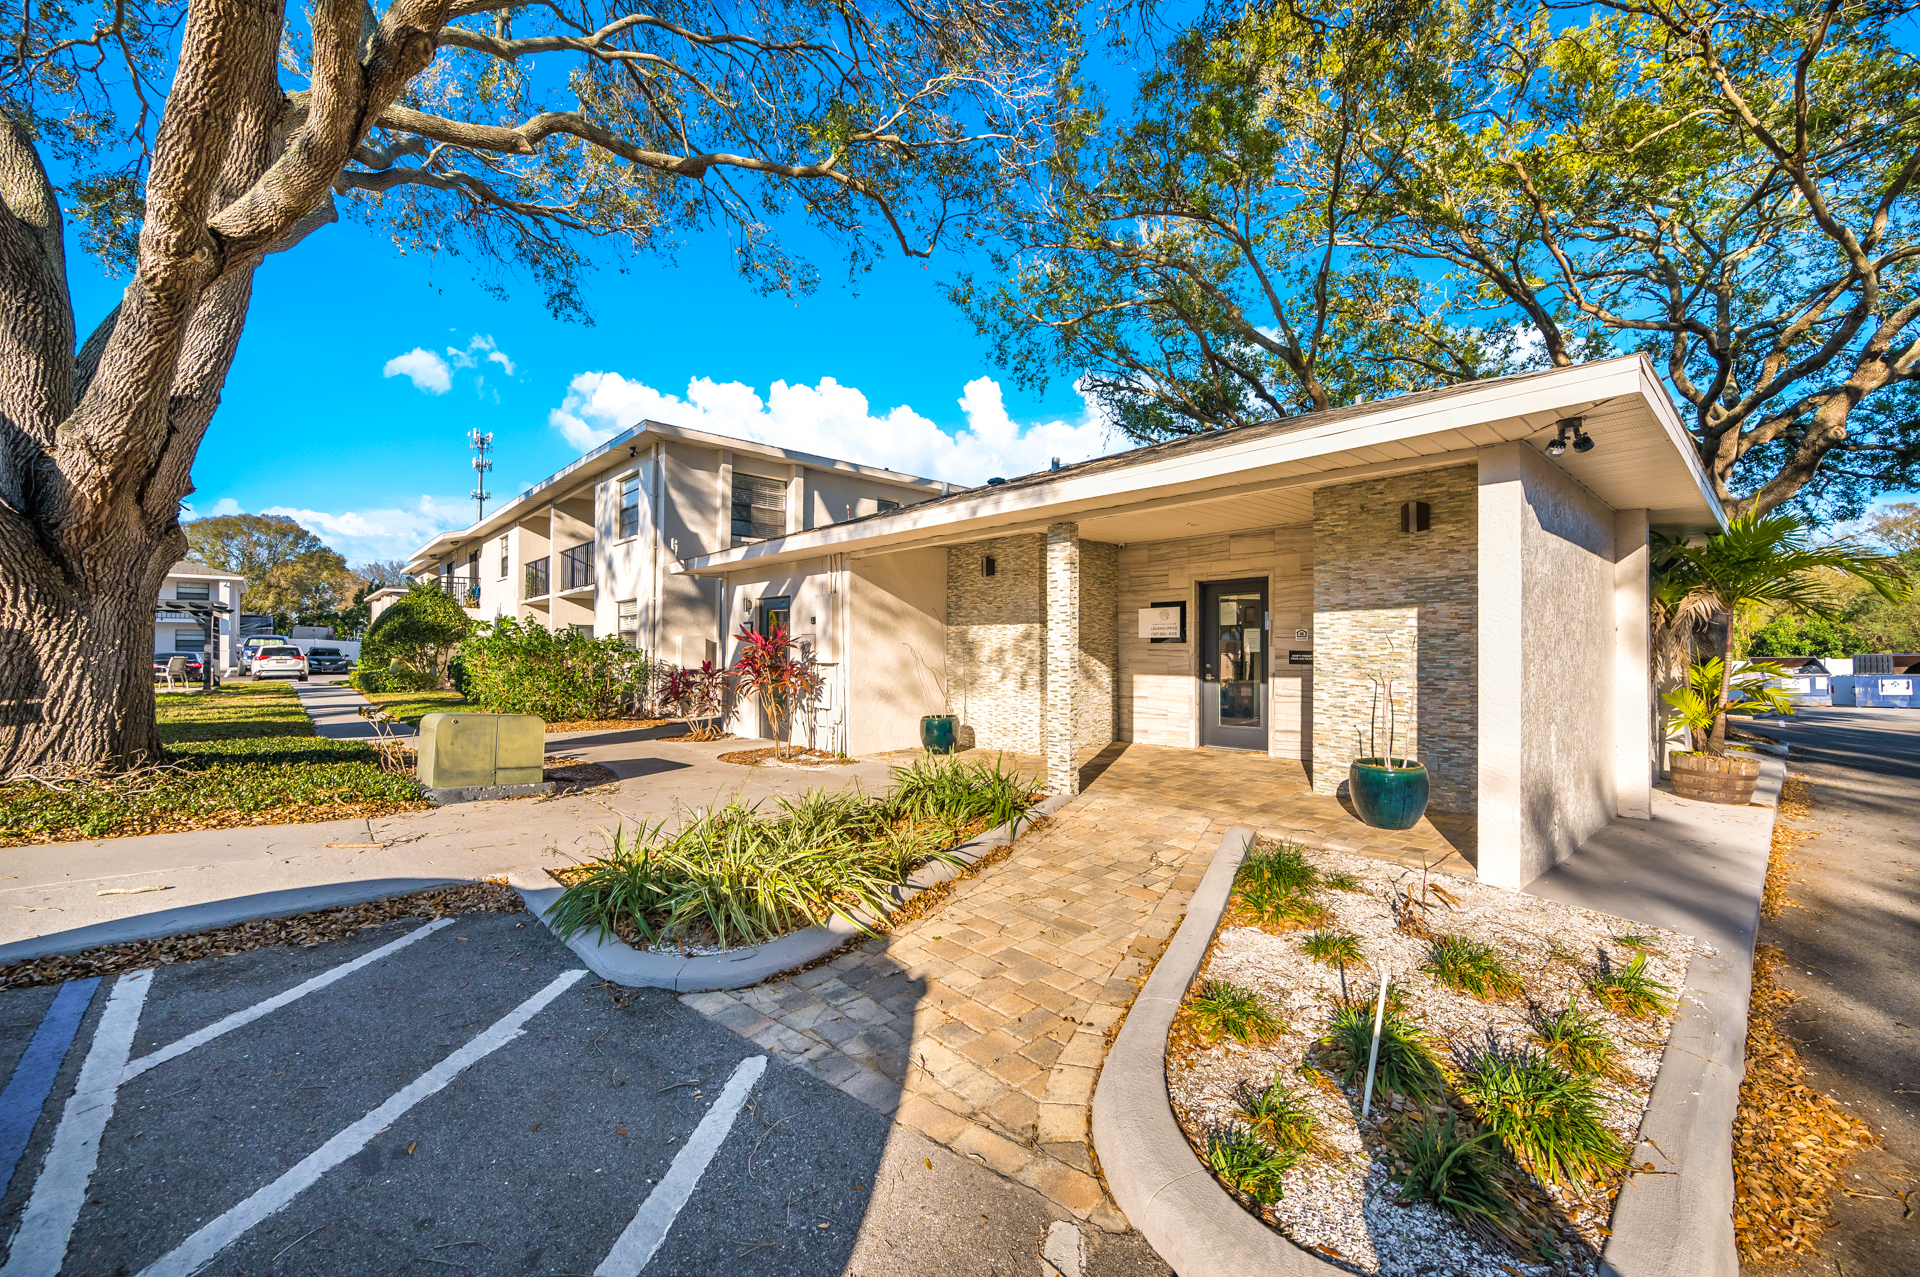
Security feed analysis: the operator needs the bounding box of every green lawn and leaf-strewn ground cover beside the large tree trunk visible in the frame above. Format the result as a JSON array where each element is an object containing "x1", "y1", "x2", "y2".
[{"x1": 0, "y1": 684, "x2": 426, "y2": 847}]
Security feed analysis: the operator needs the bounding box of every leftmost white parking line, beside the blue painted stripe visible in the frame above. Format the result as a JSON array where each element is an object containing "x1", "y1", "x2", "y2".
[{"x1": 0, "y1": 970, "x2": 154, "y2": 1277}]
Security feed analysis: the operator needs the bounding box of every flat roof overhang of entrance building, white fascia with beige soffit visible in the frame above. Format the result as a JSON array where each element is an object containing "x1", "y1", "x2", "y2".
[{"x1": 674, "y1": 355, "x2": 1724, "y2": 576}]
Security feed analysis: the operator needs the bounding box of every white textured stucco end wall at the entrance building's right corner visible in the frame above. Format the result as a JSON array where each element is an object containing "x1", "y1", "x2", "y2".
[{"x1": 1478, "y1": 444, "x2": 1612, "y2": 889}]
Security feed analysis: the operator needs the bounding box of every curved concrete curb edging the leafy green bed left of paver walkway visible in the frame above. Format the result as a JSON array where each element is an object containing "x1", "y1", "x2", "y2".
[{"x1": 520, "y1": 795, "x2": 1071, "y2": 993}]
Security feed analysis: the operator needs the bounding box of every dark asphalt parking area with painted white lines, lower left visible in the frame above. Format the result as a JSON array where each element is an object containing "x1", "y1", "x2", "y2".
[{"x1": 0, "y1": 914, "x2": 1167, "y2": 1277}]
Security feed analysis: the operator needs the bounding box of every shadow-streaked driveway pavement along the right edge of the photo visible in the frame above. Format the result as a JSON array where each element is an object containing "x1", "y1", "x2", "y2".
[{"x1": 1755, "y1": 709, "x2": 1920, "y2": 1277}]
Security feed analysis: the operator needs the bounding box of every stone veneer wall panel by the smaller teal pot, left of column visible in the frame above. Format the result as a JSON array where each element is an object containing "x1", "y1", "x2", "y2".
[{"x1": 947, "y1": 534, "x2": 1046, "y2": 755}]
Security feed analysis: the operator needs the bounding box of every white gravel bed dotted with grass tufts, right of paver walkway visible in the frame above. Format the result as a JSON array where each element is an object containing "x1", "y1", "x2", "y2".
[{"x1": 1167, "y1": 843, "x2": 1693, "y2": 1277}]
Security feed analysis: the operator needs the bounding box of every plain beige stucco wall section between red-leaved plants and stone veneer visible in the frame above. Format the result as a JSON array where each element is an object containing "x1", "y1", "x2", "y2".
[{"x1": 845, "y1": 549, "x2": 947, "y2": 755}]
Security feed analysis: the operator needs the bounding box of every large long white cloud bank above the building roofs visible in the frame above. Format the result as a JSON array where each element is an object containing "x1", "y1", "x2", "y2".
[{"x1": 547, "y1": 373, "x2": 1125, "y2": 484}]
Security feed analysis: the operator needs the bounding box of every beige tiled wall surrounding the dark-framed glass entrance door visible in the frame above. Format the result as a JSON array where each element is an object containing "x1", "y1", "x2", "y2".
[{"x1": 1116, "y1": 524, "x2": 1313, "y2": 759}]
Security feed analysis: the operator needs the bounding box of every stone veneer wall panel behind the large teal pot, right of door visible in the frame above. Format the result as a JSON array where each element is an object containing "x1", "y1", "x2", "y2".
[{"x1": 1313, "y1": 465, "x2": 1474, "y2": 812}]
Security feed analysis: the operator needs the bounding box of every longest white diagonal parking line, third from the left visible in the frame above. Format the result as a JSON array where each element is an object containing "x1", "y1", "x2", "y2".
[{"x1": 133, "y1": 970, "x2": 586, "y2": 1277}]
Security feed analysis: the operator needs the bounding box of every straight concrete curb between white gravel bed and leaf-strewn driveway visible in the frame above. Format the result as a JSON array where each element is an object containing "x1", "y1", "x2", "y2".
[{"x1": 1599, "y1": 745, "x2": 1788, "y2": 1277}]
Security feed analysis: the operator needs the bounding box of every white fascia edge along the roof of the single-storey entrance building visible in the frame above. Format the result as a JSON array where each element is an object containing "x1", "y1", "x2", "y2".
[{"x1": 672, "y1": 353, "x2": 1726, "y2": 576}]
